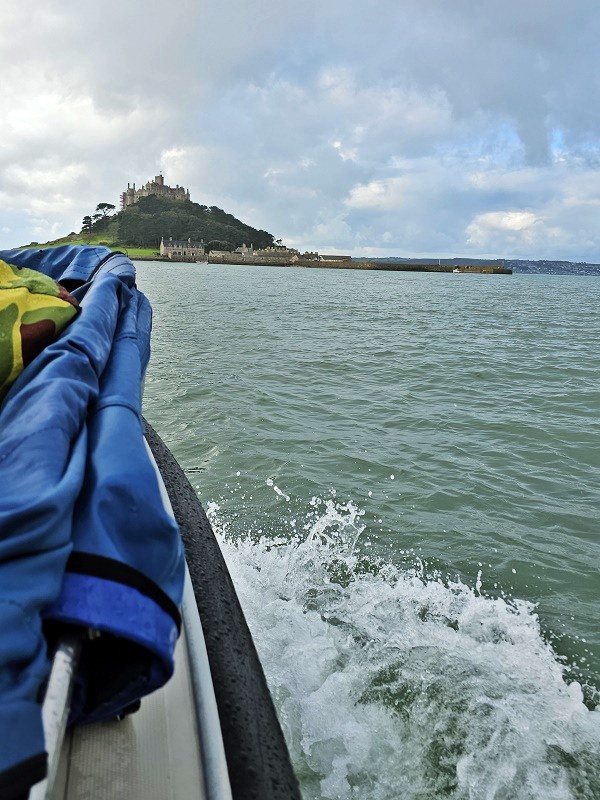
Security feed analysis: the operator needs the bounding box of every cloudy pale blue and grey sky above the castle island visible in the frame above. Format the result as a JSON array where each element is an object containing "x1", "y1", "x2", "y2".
[{"x1": 0, "y1": 0, "x2": 600, "y2": 262}]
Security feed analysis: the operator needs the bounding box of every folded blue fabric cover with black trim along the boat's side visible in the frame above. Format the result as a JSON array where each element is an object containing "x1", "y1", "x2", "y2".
[{"x1": 0, "y1": 246, "x2": 184, "y2": 798}]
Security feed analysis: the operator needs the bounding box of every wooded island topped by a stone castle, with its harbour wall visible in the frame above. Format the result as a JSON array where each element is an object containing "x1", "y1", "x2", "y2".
[{"x1": 25, "y1": 174, "x2": 512, "y2": 275}]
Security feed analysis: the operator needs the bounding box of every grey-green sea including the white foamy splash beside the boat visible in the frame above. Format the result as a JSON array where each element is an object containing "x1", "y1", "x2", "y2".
[{"x1": 137, "y1": 262, "x2": 600, "y2": 800}]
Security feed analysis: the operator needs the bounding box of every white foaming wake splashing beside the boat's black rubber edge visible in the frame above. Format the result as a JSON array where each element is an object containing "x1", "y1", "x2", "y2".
[{"x1": 207, "y1": 498, "x2": 600, "y2": 800}]
